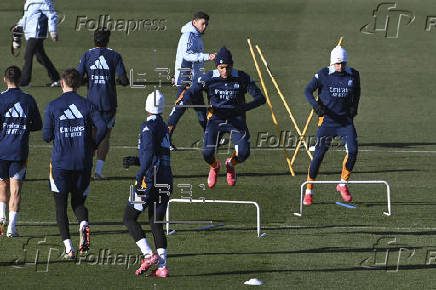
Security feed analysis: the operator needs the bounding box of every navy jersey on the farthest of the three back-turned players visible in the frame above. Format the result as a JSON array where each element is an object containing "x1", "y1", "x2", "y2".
[{"x1": 77, "y1": 47, "x2": 126, "y2": 111}]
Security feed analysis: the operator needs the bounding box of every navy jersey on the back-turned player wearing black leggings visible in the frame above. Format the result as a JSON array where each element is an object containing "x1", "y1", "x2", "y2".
[{"x1": 42, "y1": 92, "x2": 106, "y2": 170}]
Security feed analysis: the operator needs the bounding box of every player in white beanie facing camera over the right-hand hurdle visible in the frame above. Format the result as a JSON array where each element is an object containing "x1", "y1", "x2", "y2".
[{"x1": 303, "y1": 46, "x2": 360, "y2": 205}]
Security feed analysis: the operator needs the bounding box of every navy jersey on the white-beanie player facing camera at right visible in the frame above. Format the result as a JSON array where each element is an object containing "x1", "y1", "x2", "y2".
[{"x1": 304, "y1": 66, "x2": 360, "y2": 126}]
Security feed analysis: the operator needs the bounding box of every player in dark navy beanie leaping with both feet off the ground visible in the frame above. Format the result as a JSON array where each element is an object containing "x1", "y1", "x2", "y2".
[{"x1": 182, "y1": 47, "x2": 266, "y2": 188}]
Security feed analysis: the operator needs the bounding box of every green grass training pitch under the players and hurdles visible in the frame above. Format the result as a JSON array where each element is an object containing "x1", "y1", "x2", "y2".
[{"x1": 0, "y1": 0, "x2": 436, "y2": 289}]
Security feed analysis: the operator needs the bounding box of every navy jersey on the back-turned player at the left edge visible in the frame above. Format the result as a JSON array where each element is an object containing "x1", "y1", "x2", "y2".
[{"x1": 0, "y1": 88, "x2": 42, "y2": 161}]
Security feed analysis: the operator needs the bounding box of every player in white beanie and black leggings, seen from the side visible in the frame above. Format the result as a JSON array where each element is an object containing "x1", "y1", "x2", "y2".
[{"x1": 123, "y1": 90, "x2": 173, "y2": 278}]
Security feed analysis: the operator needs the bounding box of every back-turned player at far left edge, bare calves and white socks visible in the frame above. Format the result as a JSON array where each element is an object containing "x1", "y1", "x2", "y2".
[{"x1": 0, "y1": 66, "x2": 42, "y2": 237}]
